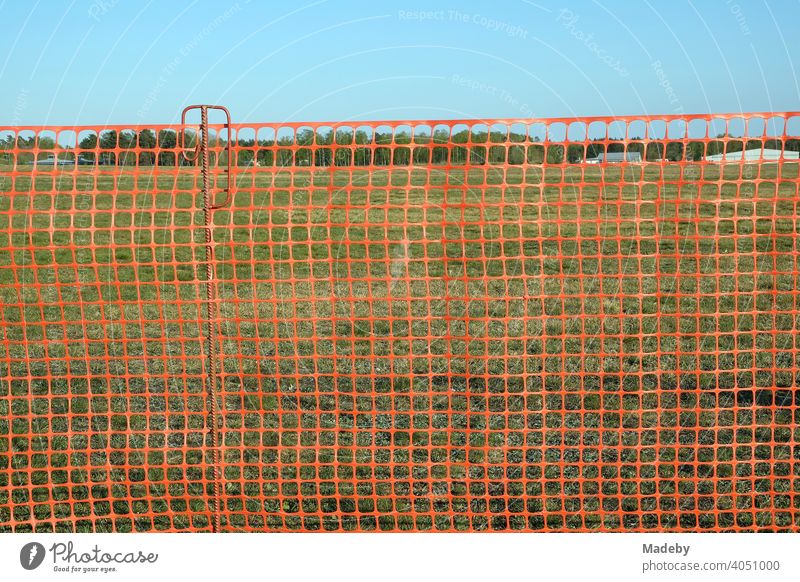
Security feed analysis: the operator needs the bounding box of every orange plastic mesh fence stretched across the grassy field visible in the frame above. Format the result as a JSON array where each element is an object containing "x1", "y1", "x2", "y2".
[{"x1": 0, "y1": 113, "x2": 800, "y2": 531}]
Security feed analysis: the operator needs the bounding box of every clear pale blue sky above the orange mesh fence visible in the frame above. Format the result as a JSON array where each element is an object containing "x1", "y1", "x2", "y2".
[{"x1": 0, "y1": 0, "x2": 800, "y2": 125}]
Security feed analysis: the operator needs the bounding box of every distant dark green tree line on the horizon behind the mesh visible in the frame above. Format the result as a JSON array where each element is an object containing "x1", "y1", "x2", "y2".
[{"x1": 0, "y1": 129, "x2": 800, "y2": 166}]
